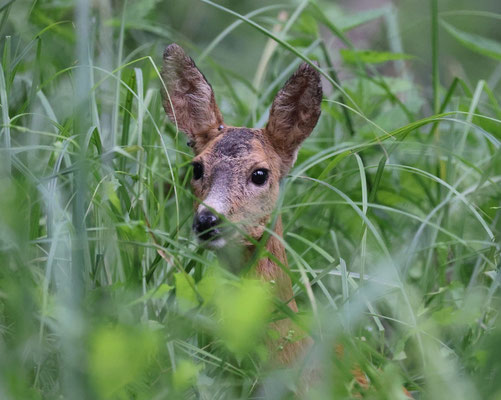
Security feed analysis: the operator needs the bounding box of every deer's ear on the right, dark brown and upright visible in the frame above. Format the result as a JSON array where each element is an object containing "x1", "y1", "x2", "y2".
[{"x1": 265, "y1": 63, "x2": 322, "y2": 176}]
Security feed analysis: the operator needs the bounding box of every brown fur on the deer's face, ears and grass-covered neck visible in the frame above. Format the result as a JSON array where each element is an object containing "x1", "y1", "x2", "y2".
[{"x1": 162, "y1": 44, "x2": 322, "y2": 364}]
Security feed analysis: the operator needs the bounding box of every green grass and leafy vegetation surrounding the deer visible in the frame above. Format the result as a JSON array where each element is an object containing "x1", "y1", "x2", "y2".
[{"x1": 0, "y1": 0, "x2": 501, "y2": 400}]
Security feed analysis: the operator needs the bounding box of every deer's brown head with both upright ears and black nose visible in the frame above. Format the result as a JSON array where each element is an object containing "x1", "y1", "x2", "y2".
[{"x1": 162, "y1": 44, "x2": 322, "y2": 248}]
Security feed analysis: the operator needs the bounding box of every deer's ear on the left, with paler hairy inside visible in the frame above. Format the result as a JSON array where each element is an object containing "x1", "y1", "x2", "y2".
[{"x1": 162, "y1": 43, "x2": 223, "y2": 153}]
